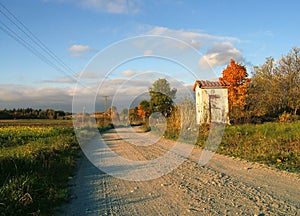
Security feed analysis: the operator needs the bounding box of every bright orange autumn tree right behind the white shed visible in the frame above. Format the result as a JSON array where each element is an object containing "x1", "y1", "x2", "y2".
[{"x1": 220, "y1": 59, "x2": 250, "y2": 122}]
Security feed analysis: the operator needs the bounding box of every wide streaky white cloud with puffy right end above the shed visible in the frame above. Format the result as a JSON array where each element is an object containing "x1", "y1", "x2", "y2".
[{"x1": 141, "y1": 26, "x2": 244, "y2": 69}]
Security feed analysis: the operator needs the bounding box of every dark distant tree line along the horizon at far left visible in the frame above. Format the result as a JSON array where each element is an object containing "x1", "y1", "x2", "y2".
[{"x1": 0, "y1": 108, "x2": 71, "y2": 119}]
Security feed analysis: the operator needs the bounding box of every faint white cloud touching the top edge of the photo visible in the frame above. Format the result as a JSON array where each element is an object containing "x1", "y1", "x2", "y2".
[{"x1": 44, "y1": 0, "x2": 141, "y2": 14}]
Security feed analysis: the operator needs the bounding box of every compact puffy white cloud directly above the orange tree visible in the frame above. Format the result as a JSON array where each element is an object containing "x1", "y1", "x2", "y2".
[{"x1": 199, "y1": 42, "x2": 243, "y2": 68}]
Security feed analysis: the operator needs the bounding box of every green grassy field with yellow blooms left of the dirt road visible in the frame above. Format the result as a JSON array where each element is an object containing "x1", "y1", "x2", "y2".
[{"x1": 0, "y1": 120, "x2": 79, "y2": 215}]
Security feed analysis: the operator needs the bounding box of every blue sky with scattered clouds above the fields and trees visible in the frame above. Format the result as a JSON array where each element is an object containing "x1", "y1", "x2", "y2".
[{"x1": 0, "y1": 0, "x2": 300, "y2": 111}]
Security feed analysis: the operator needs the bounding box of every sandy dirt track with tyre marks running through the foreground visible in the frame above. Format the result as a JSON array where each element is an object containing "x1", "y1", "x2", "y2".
[{"x1": 58, "y1": 128, "x2": 300, "y2": 215}]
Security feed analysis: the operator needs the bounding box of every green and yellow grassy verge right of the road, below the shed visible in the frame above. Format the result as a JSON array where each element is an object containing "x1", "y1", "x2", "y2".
[{"x1": 217, "y1": 121, "x2": 300, "y2": 173}]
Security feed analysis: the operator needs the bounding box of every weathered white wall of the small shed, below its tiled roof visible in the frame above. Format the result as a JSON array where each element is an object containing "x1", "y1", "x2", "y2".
[{"x1": 195, "y1": 86, "x2": 229, "y2": 124}]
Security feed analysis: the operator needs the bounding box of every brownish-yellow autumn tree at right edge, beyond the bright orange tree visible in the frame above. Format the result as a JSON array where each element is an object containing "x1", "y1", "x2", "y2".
[{"x1": 247, "y1": 48, "x2": 300, "y2": 118}]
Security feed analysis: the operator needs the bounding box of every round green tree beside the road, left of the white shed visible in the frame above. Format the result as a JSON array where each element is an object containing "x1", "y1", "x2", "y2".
[{"x1": 149, "y1": 79, "x2": 177, "y2": 116}]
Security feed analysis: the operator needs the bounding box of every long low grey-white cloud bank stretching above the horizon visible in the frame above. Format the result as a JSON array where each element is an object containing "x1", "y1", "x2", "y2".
[{"x1": 0, "y1": 75, "x2": 193, "y2": 112}]
